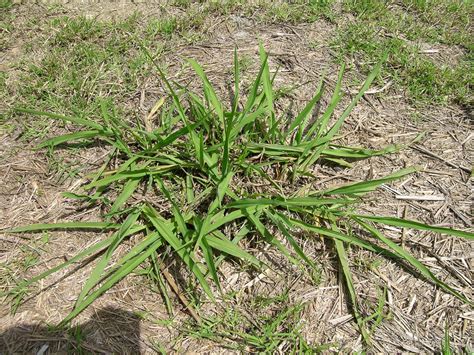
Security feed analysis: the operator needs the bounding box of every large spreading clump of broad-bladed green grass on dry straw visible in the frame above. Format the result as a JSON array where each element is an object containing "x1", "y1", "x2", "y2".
[{"x1": 5, "y1": 43, "x2": 474, "y2": 343}]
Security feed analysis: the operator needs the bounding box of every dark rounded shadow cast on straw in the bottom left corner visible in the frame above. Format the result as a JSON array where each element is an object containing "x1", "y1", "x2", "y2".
[{"x1": 0, "y1": 307, "x2": 140, "y2": 355}]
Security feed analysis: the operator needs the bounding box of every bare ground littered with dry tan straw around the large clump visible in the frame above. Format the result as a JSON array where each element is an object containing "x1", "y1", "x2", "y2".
[{"x1": 0, "y1": 1, "x2": 474, "y2": 354}]
